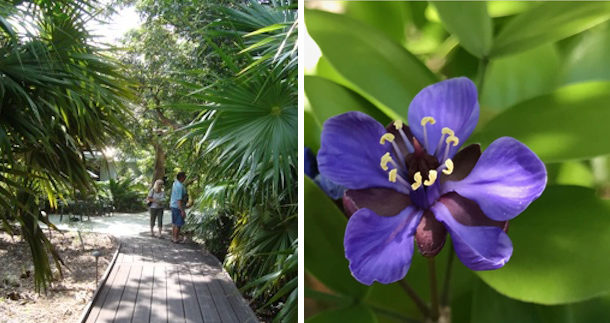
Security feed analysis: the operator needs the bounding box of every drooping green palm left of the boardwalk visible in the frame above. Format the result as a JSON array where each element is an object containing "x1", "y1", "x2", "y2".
[{"x1": 0, "y1": 0, "x2": 132, "y2": 290}]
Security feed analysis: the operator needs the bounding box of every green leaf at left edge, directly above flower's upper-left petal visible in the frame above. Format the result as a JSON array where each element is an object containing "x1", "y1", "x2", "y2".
[{"x1": 304, "y1": 76, "x2": 391, "y2": 124}]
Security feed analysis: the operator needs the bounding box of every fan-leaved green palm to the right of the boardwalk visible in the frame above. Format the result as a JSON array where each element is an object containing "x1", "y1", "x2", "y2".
[{"x1": 176, "y1": 1, "x2": 298, "y2": 322}]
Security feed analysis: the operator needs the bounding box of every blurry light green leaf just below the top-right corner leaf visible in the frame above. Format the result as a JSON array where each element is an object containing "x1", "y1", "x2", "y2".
[{"x1": 481, "y1": 44, "x2": 561, "y2": 109}]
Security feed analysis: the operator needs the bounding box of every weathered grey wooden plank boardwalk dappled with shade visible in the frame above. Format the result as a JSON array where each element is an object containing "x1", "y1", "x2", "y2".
[{"x1": 83, "y1": 238, "x2": 258, "y2": 323}]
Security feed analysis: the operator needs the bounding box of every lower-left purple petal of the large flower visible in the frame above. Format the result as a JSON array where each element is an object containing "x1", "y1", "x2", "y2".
[{"x1": 343, "y1": 207, "x2": 422, "y2": 285}]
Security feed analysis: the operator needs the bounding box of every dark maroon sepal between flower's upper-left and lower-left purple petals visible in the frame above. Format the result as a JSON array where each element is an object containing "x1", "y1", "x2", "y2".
[{"x1": 343, "y1": 187, "x2": 411, "y2": 217}]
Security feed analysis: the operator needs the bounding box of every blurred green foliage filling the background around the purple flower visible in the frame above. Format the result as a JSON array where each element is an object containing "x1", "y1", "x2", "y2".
[{"x1": 301, "y1": 1, "x2": 610, "y2": 323}]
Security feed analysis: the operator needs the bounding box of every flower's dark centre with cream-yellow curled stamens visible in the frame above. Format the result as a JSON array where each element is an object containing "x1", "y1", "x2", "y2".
[{"x1": 379, "y1": 117, "x2": 459, "y2": 209}]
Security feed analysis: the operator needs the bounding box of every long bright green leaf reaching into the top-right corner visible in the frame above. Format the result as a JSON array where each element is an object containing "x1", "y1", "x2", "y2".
[{"x1": 490, "y1": 1, "x2": 610, "y2": 57}]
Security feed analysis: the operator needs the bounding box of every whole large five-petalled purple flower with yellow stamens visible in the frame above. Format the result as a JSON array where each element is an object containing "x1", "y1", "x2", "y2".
[{"x1": 318, "y1": 77, "x2": 547, "y2": 285}]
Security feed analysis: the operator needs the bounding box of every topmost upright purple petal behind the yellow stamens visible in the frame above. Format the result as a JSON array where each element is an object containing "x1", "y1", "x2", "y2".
[{"x1": 408, "y1": 77, "x2": 479, "y2": 157}]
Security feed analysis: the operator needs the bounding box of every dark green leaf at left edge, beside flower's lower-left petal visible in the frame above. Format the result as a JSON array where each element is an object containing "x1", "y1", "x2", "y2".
[{"x1": 304, "y1": 177, "x2": 368, "y2": 298}]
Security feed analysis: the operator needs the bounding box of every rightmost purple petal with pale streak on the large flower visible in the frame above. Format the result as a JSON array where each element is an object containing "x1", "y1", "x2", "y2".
[{"x1": 442, "y1": 137, "x2": 547, "y2": 221}]
